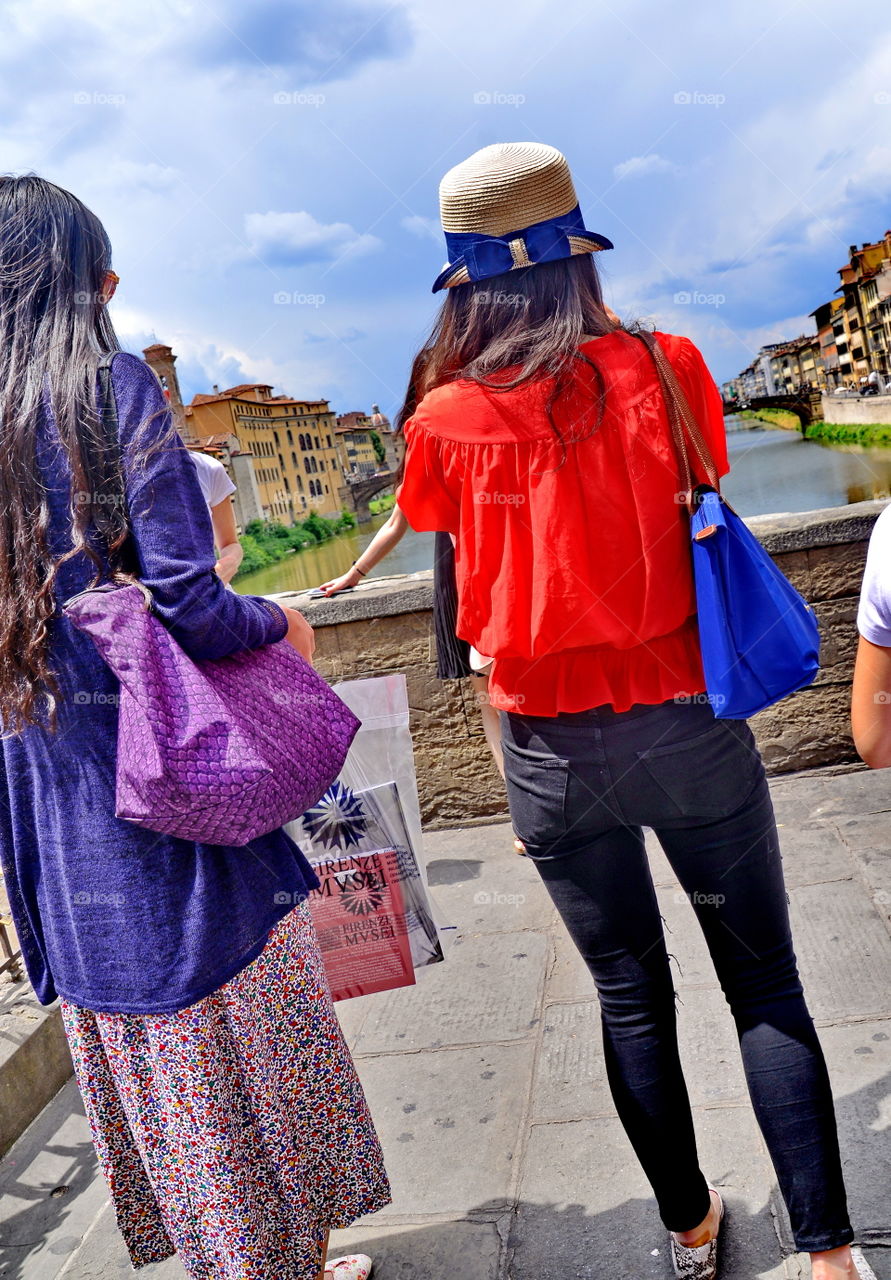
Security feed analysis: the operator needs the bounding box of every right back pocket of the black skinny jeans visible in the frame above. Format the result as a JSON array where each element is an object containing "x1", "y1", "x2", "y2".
[{"x1": 638, "y1": 719, "x2": 763, "y2": 822}]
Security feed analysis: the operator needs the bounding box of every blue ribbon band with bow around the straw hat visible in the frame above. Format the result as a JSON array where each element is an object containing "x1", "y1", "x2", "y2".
[{"x1": 433, "y1": 205, "x2": 613, "y2": 293}]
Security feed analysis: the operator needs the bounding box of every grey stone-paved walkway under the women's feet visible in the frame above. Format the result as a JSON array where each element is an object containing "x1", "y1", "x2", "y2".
[{"x1": 0, "y1": 771, "x2": 891, "y2": 1280}]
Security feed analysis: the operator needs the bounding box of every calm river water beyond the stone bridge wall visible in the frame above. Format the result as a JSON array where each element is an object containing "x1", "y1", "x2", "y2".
[{"x1": 234, "y1": 416, "x2": 891, "y2": 595}]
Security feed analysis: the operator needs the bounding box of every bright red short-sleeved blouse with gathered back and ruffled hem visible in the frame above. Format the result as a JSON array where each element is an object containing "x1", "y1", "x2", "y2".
[{"x1": 398, "y1": 330, "x2": 730, "y2": 716}]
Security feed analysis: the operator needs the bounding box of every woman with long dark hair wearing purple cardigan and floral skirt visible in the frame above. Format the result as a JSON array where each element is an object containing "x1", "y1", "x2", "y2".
[{"x1": 0, "y1": 177, "x2": 389, "y2": 1280}]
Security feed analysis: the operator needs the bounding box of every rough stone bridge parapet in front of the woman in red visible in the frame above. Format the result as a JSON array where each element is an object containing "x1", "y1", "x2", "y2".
[{"x1": 277, "y1": 502, "x2": 885, "y2": 827}]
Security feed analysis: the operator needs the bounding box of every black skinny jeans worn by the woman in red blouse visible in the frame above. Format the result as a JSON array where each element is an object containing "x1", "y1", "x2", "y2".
[{"x1": 502, "y1": 699, "x2": 853, "y2": 1252}]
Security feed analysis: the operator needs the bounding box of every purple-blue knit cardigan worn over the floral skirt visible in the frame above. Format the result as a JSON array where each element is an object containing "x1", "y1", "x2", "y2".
[{"x1": 0, "y1": 353, "x2": 316, "y2": 1014}]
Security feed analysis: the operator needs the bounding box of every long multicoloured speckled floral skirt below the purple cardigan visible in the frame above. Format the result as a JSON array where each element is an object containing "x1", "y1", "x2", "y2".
[{"x1": 61, "y1": 904, "x2": 389, "y2": 1280}]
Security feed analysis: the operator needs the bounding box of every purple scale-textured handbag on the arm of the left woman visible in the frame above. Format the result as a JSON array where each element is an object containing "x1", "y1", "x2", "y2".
[{"x1": 64, "y1": 584, "x2": 360, "y2": 845}]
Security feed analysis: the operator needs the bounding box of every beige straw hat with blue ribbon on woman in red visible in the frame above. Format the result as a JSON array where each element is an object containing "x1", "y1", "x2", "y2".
[{"x1": 433, "y1": 142, "x2": 612, "y2": 293}]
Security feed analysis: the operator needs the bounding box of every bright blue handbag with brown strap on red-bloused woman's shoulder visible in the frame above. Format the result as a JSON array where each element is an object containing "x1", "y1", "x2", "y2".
[{"x1": 639, "y1": 333, "x2": 819, "y2": 719}]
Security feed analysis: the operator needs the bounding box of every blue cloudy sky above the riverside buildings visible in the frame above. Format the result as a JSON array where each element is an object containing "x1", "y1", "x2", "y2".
[{"x1": 0, "y1": 0, "x2": 891, "y2": 415}]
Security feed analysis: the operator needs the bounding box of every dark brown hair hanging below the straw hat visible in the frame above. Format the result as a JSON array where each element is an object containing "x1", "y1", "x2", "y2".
[{"x1": 396, "y1": 253, "x2": 636, "y2": 436}]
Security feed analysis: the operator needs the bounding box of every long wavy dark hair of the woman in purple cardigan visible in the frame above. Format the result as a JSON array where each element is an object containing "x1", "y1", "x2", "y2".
[{"x1": 0, "y1": 174, "x2": 127, "y2": 733}]
